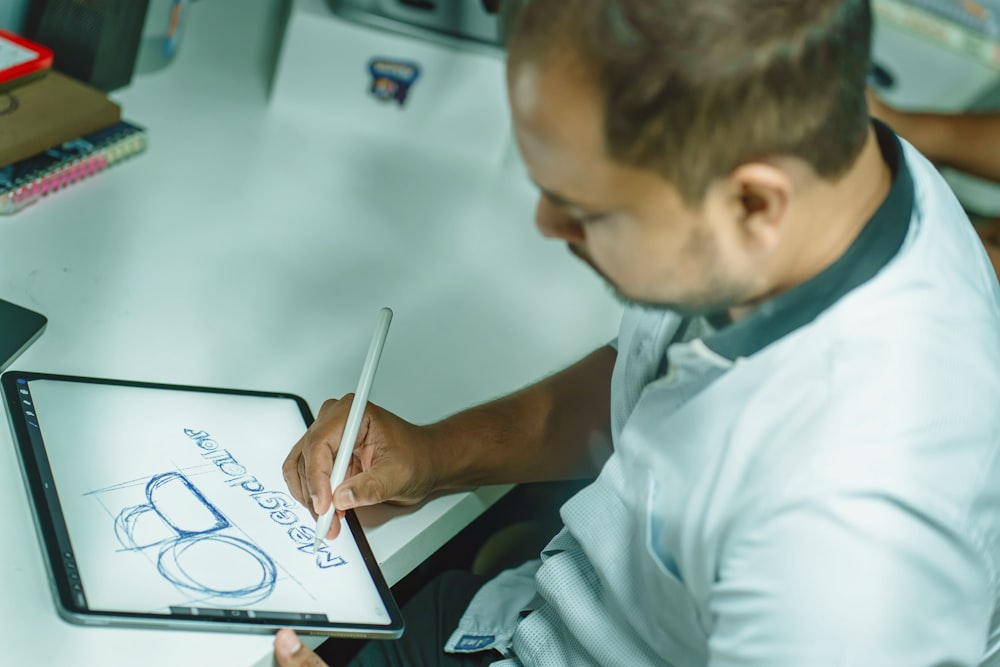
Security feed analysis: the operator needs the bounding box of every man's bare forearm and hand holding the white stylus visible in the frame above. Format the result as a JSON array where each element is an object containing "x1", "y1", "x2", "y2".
[{"x1": 282, "y1": 346, "x2": 617, "y2": 539}]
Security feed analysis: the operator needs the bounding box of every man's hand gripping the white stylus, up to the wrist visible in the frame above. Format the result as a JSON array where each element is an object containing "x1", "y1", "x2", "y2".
[{"x1": 282, "y1": 394, "x2": 435, "y2": 539}]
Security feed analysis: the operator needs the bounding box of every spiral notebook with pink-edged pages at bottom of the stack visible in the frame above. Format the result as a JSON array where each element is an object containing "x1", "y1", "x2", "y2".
[{"x1": 0, "y1": 121, "x2": 146, "y2": 215}]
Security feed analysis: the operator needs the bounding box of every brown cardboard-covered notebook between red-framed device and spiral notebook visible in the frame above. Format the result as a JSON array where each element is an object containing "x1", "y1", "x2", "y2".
[{"x1": 0, "y1": 71, "x2": 121, "y2": 167}]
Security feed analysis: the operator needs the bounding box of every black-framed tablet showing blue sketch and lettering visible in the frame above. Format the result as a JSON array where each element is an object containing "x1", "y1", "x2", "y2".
[{"x1": 2, "y1": 371, "x2": 403, "y2": 639}]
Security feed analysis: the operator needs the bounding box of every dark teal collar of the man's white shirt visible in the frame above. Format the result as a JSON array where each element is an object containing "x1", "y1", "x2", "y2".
[{"x1": 703, "y1": 121, "x2": 914, "y2": 360}]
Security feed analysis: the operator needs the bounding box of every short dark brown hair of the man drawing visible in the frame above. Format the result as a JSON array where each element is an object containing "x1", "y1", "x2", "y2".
[{"x1": 505, "y1": 0, "x2": 872, "y2": 203}]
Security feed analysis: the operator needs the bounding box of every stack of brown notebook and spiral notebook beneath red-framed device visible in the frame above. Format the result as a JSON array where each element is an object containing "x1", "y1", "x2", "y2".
[{"x1": 0, "y1": 29, "x2": 146, "y2": 214}]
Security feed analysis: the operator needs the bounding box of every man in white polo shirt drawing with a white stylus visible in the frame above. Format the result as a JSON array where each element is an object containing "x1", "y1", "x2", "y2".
[{"x1": 275, "y1": 0, "x2": 1000, "y2": 667}]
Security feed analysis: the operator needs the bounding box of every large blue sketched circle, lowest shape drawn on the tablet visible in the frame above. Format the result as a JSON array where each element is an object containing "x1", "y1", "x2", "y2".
[{"x1": 157, "y1": 535, "x2": 278, "y2": 604}]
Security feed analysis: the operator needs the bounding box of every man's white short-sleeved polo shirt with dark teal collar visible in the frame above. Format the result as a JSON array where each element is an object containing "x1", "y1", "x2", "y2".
[{"x1": 446, "y1": 124, "x2": 1000, "y2": 667}]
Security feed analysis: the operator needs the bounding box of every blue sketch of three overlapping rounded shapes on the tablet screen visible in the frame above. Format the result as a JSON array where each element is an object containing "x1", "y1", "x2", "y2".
[{"x1": 107, "y1": 472, "x2": 277, "y2": 605}]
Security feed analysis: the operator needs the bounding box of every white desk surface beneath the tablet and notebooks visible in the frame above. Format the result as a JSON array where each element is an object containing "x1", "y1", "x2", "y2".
[{"x1": 0, "y1": 0, "x2": 620, "y2": 667}]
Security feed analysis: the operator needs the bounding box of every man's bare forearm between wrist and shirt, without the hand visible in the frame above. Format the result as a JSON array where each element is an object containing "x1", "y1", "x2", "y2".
[{"x1": 430, "y1": 347, "x2": 616, "y2": 489}]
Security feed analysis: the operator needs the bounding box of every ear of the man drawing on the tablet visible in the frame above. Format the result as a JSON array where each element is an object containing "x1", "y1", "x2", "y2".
[{"x1": 726, "y1": 162, "x2": 794, "y2": 252}]
